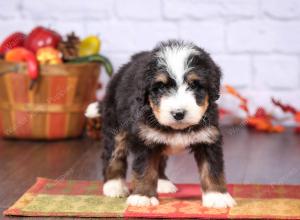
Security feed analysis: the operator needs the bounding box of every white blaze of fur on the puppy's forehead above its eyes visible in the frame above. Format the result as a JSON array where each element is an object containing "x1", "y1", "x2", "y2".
[{"x1": 157, "y1": 44, "x2": 199, "y2": 84}]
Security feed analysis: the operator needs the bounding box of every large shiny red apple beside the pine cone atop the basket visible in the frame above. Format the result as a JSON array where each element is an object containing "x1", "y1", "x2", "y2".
[{"x1": 24, "y1": 26, "x2": 62, "y2": 52}]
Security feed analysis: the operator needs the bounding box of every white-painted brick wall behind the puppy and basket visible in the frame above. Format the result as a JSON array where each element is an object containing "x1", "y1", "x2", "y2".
[{"x1": 0, "y1": 0, "x2": 300, "y2": 122}]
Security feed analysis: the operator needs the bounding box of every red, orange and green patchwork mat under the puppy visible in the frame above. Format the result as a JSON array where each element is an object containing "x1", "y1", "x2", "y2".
[{"x1": 3, "y1": 178, "x2": 300, "y2": 219}]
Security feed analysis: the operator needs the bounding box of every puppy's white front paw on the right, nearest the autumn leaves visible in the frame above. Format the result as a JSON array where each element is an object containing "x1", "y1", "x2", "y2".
[{"x1": 202, "y1": 192, "x2": 236, "y2": 208}]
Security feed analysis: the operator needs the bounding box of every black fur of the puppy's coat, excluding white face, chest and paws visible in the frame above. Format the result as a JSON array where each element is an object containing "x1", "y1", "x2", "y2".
[{"x1": 101, "y1": 41, "x2": 226, "y2": 199}]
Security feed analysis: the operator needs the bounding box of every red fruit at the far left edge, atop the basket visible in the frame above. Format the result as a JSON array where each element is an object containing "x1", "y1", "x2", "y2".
[{"x1": 0, "y1": 32, "x2": 26, "y2": 54}]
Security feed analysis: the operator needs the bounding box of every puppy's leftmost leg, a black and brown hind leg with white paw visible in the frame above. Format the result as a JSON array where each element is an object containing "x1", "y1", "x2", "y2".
[{"x1": 102, "y1": 132, "x2": 129, "y2": 197}]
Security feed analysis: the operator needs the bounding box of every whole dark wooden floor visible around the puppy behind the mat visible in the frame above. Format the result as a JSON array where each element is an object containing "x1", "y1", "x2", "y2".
[{"x1": 0, "y1": 127, "x2": 300, "y2": 217}]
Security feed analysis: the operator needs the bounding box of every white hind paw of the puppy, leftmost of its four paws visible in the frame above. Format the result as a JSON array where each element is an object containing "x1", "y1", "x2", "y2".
[{"x1": 103, "y1": 179, "x2": 129, "y2": 197}]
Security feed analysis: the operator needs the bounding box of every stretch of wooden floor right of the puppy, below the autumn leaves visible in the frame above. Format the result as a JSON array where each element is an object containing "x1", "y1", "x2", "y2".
[{"x1": 223, "y1": 128, "x2": 300, "y2": 184}]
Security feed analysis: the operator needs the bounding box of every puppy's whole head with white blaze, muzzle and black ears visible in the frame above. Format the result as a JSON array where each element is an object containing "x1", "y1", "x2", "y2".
[{"x1": 148, "y1": 41, "x2": 221, "y2": 130}]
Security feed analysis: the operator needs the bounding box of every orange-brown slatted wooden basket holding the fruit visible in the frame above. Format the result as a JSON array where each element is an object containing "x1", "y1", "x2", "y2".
[{"x1": 0, "y1": 61, "x2": 100, "y2": 140}]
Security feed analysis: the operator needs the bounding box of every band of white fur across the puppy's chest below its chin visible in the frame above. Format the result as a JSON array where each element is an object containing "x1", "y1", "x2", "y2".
[{"x1": 139, "y1": 125, "x2": 220, "y2": 153}]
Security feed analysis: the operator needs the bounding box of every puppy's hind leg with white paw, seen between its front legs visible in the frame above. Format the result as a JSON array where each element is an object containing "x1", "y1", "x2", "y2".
[{"x1": 156, "y1": 155, "x2": 177, "y2": 193}]
